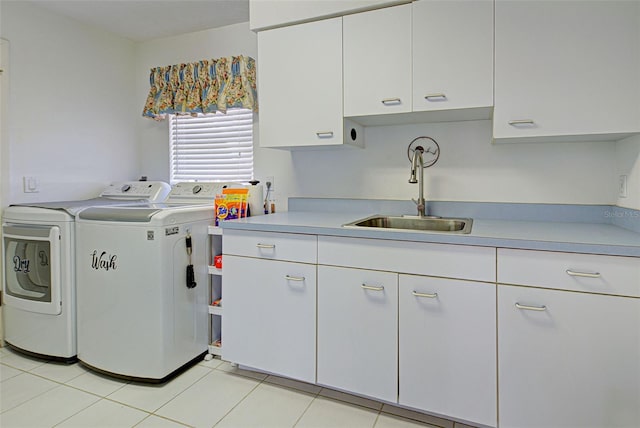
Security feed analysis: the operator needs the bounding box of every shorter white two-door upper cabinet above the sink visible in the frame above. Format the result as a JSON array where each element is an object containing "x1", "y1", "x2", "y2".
[{"x1": 343, "y1": 0, "x2": 493, "y2": 125}]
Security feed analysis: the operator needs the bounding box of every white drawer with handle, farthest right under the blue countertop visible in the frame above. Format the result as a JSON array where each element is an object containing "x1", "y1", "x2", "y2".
[{"x1": 498, "y1": 249, "x2": 640, "y2": 297}]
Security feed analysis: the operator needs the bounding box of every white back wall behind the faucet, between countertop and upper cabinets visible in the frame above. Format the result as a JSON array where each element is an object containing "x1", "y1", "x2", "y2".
[{"x1": 288, "y1": 120, "x2": 616, "y2": 204}]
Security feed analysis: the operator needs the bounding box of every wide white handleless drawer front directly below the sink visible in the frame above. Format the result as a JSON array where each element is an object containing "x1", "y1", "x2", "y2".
[{"x1": 318, "y1": 236, "x2": 496, "y2": 282}]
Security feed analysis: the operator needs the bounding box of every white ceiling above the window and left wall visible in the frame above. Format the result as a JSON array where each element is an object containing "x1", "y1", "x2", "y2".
[{"x1": 31, "y1": 0, "x2": 249, "y2": 42}]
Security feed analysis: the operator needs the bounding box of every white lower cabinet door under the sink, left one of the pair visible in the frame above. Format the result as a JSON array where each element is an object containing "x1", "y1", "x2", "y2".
[{"x1": 318, "y1": 266, "x2": 398, "y2": 402}]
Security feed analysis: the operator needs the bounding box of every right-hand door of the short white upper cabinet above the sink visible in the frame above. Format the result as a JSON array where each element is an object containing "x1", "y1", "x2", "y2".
[{"x1": 412, "y1": 0, "x2": 493, "y2": 113}]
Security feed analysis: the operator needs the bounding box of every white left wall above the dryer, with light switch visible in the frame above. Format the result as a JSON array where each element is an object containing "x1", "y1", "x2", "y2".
[{"x1": 0, "y1": 2, "x2": 139, "y2": 203}]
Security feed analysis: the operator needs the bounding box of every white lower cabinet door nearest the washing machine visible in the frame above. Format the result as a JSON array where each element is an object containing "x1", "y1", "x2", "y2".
[{"x1": 222, "y1": 255, "x2": 316, "y2": 383}]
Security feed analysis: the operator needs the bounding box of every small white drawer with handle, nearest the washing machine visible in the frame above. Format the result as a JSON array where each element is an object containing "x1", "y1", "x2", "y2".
[{"x1": 222, "y1": 230, "x2": 318, "y2": 263}]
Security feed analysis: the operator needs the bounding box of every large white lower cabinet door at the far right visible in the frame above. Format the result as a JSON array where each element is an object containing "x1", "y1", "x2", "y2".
[{"x1": 498, "y1": 285, "x2": 640, "y2": 428}]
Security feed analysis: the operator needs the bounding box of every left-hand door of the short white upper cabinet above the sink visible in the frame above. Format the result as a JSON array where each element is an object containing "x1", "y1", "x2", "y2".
[{"x1": 343, "y1": 4, "x2": 411, "y2": 117}]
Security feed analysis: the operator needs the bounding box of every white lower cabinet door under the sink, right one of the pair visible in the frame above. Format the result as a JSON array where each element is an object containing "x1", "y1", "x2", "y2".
[{"x1": 398, "y1": 275, "x2": 497, "y2": 427}]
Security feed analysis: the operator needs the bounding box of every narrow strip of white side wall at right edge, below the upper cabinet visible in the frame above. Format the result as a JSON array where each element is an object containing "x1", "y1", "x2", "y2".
[{"x1": 616, "y1": 135, "x2": 640, "y2": 210}]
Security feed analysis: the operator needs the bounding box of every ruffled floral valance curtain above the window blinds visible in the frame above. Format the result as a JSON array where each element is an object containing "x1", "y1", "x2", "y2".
[{"x1": 142, "y1": 55, "x2": 258, "y2": 120}]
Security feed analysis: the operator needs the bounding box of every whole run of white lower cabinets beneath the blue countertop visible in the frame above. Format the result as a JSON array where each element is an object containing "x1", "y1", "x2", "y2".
[{"x1": 222, "y1": 230, "x2": 640, "y2": 428}]
